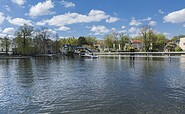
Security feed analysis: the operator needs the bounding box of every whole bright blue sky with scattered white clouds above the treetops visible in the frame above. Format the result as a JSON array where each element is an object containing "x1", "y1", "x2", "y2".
[{"x1": 0, "y1": 0, "x2": 185, "y2": 39}]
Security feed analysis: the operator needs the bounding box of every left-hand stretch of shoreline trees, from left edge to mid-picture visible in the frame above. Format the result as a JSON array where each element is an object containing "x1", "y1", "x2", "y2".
[{"x1": 0, "y1": 24, "x2": 97, "y2": 55}]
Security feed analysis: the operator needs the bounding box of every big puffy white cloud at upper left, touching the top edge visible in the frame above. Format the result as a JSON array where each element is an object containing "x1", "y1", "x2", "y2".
[{"x1": 28, "y1": 0, "x2": 54, "y2": 17}]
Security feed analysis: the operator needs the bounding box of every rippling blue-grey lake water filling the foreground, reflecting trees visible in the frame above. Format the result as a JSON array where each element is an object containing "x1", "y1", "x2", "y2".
[{"x1": 0, "y1": 56, "x2": 185, "y2": 114}]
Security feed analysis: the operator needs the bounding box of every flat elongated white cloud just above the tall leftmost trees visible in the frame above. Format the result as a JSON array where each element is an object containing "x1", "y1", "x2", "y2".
[{"x1": 7, "y1": 17, "x2": 32, "y2": 26}]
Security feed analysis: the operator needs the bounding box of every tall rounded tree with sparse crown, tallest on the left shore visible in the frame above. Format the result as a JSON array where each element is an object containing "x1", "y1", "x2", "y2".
[{"x1": 15, "y1": 24, "x2": 33, "y2": 55}]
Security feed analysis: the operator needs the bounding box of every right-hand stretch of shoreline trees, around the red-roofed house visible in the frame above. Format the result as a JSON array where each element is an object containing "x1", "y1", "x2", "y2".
[{"x1": 104, "y1": 26, "x2": 185, "y2": 52}]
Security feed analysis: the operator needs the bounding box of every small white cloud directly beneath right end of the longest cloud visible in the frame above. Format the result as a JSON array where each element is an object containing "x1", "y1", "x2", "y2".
[{"x1": 91, "y1": 25, "x2": 110, "y2": 35}]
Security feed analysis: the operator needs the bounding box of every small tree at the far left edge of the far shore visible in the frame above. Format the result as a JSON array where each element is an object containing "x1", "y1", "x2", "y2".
[{"x1": 0, "y1": 35, "x2": 11, "y2": 55}]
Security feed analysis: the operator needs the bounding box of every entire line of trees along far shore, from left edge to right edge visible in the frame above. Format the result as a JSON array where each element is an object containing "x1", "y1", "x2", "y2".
[{"x1": 0, "y1": 24, "x2": 185, "y2": 55}]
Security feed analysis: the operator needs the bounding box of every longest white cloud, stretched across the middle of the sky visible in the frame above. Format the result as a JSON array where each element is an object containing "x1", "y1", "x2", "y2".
[{"x1": 43, "y1": 10, "x2": 115, "y2": 26}]
